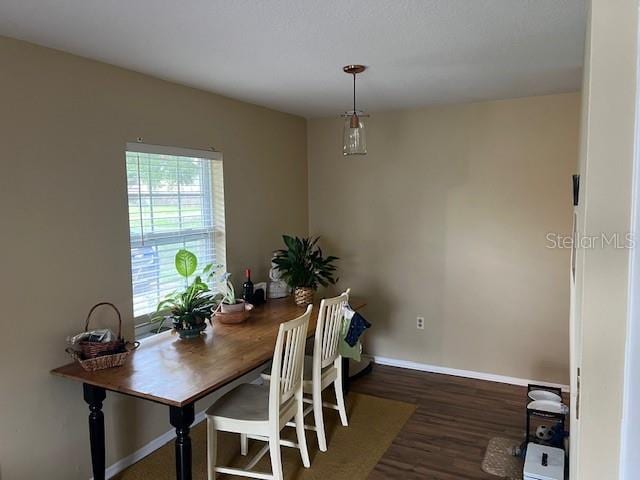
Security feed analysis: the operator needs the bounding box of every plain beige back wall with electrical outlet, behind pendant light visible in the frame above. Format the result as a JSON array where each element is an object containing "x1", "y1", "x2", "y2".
[{"x1": 307, "y1": 93, "x2": 580, "y2": 384}]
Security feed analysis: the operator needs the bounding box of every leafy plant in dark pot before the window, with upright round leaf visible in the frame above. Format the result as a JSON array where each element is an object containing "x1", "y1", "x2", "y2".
[{"x1": 151, "y1": 249, "x2": 219, "y2": 339}]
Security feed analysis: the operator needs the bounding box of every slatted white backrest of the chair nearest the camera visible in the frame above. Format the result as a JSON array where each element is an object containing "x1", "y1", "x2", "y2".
[{"x1": 269, "y1": 305, "x2": 313, "y2": 415}]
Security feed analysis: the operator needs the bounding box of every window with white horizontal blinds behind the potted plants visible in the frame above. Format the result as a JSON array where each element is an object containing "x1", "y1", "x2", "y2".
[{"x1": 126, "y1": 143, "x2": 226, "y2": 335}]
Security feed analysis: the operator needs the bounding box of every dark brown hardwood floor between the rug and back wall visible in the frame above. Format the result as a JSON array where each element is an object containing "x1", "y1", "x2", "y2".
[{"x1": 351, "y1": 365, "x2": 527, "y2": 480}]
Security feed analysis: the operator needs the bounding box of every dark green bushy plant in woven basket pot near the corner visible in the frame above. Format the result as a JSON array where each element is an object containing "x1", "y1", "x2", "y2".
[{"x1": 273, "y1": 235, "x2": 338, "y2": 306}]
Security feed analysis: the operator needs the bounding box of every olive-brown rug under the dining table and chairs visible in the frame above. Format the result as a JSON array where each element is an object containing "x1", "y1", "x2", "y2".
[{"x1": 113, "y1": 393, "x2": 415, "y2": 480}]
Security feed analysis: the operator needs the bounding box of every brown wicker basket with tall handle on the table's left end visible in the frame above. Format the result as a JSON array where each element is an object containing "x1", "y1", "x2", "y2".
[{"x1": 67, "y1": 302, "x2": 140, "y2": 372}]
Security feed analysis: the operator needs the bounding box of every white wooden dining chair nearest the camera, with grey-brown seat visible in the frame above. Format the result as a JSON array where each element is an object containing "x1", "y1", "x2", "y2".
[{"x1": 206, "y1": 305, "x2": 312, "y2": 480}]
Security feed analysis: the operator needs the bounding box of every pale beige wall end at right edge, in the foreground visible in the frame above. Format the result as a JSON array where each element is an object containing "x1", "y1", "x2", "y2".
[{"x1": 572, "y1": 0, "x2": 638, "y2": 480}]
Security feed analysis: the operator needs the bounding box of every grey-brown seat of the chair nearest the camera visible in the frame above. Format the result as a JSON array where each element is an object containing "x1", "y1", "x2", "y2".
[{"x1": 207, "y1": 383, "x2": 269, "y2": 422}]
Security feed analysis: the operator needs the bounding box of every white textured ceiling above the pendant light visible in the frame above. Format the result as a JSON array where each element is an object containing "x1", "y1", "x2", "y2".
[{"x1": 0, "y1": 0, "x2": 586, "y2": 117}]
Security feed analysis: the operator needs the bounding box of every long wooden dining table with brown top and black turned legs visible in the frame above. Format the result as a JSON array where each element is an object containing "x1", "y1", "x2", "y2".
[{"x1": 51, "y1": 297, "x2": 365, "y2": 480}]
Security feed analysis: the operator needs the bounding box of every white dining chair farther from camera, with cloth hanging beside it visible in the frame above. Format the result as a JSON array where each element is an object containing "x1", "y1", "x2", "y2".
[{"x1": 262, "y1": 289, "x2": 351, "y2": 452}]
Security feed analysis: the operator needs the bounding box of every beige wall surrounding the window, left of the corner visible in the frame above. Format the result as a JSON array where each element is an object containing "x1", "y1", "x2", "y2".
[{"x1": 0, "y1": 37, "x2": 308, "y2": 480}]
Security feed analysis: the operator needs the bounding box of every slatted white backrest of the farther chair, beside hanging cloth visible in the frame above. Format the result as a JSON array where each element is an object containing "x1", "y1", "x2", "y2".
[{"x1": 313, "y1": 289, "x2": 351, "y2": 373}]
